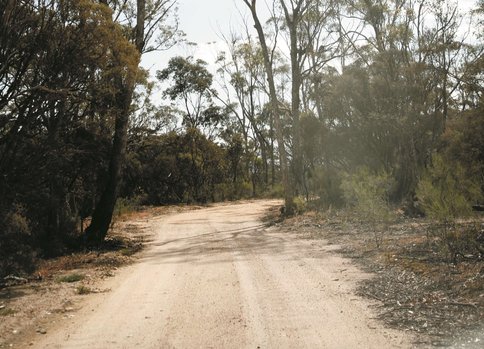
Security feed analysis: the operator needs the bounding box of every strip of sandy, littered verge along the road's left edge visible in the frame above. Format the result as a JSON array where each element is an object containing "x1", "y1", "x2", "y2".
[{"x1": 0, "y1": 207, "x2": 154, "y2": 348}]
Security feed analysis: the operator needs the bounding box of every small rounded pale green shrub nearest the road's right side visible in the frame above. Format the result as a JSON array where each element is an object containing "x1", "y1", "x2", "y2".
[{"x1": 341, "y1": 167, "x2": 394, "y2": 224}]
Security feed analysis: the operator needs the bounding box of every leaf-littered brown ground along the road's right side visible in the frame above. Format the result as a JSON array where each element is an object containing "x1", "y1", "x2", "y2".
[{"x1": 275, "y1": 212, "x2": 484, "y2": 349}]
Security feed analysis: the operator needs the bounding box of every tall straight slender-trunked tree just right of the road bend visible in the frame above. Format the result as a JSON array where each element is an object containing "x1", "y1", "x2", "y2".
[{"x1": 279, "y1": 0, "x2": 342, "y2": 197}]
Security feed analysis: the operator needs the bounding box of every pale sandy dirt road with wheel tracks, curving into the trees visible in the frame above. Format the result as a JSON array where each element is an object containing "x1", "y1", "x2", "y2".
[{"x1": 30, "y1": 201, "x2": 411, "y2": 349}]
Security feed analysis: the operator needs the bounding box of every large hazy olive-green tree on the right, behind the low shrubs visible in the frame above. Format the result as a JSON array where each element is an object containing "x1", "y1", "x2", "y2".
[{"x1": 327, "y1": 0, "x2": 472, "y2": 201}]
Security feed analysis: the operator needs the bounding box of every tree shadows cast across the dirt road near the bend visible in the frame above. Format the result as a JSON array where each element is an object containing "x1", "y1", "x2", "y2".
[{"x1": 138, "y1": 225, "x2": 312, "y2": 264}]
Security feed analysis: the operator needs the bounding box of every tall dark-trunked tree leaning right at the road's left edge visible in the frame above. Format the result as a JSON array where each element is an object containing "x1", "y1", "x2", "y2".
[{"x1": 86, "y1": 0, "x2": 177, "y2": 243}]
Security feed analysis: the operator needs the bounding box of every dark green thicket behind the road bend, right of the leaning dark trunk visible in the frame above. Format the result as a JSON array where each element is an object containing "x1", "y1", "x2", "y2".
[{"x1": 123, "y1": 128, "x2": 278, "y2": 205}]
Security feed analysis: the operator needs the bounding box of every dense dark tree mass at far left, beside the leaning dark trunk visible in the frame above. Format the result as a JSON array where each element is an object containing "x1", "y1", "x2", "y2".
[{"x1": 0, "y1": 0, "x2": 138, "y2": 260}]
